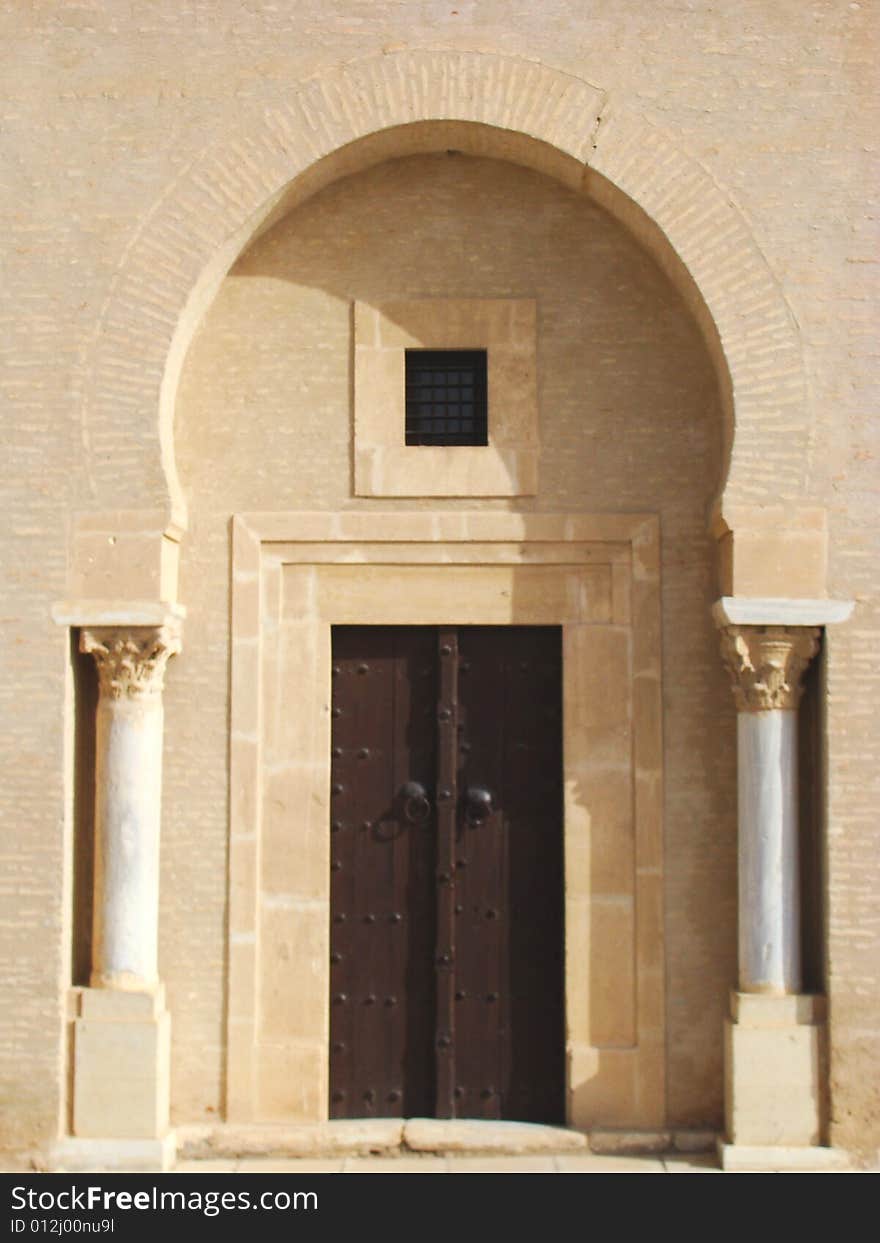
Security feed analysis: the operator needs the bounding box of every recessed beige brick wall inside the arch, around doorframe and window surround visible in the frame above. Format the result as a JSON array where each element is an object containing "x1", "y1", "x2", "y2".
[{"x1": 169, "y1": 155, "x2": 736, "y2": 1125}]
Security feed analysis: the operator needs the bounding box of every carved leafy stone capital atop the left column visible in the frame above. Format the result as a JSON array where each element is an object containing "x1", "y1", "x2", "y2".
[{"x1": 80, "y1": 622, "x2": 180, "y2": 699}]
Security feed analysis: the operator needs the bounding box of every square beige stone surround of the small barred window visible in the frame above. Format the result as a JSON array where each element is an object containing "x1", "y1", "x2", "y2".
[{"x1": 354, "y1": 298, "x2": 538, "y2": 497}]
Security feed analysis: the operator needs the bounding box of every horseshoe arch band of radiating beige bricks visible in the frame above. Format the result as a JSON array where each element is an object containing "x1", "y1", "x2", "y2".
[{"x1": 83, "y1": 51, "x2": 808, "y2": 527}]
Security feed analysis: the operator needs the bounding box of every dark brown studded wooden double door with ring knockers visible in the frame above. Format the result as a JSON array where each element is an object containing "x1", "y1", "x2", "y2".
[{"x1": 329, "y1": 626, "x2": 564, "y2": 1122}]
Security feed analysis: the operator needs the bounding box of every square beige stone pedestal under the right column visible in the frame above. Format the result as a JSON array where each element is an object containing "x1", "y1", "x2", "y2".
[{"x1": 725, "y1": 992, "x2": 832, "y2": 1143}]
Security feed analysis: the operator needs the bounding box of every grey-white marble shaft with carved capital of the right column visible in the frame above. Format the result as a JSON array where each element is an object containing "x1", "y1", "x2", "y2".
[{"x1": 721, "y1": 625, "x2": 819, "y2": 996}]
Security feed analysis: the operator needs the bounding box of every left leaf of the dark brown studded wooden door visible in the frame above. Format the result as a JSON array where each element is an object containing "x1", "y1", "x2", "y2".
[{"x1": 331, "y1": 626, "x2": 436, "y2": 1117}]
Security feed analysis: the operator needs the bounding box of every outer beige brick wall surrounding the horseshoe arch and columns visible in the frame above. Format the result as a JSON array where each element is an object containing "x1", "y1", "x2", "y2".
[{"x1": 0, "y1": 0, "x2": 880, "y2": 1146}]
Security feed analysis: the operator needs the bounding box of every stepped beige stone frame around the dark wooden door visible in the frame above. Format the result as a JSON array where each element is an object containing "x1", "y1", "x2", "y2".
[{"x1": 226, "y1": 512, "x2": 665, "y2": 1129}]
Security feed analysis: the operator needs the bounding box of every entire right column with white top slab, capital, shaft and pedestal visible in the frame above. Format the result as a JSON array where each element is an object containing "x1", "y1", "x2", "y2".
[{"x1": 712, "y1": 597, "x2": 853, "y2": 1170}]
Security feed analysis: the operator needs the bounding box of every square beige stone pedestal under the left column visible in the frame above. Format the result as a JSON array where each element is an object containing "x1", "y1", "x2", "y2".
[{"x1": 72, "y1": 986, "x2": 170, "y2": 1151}]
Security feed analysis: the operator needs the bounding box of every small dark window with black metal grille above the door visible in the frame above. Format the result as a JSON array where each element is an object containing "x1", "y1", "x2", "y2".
[{"x1": 406, "y1": 349, "x2": 488, "y2": 445}]
